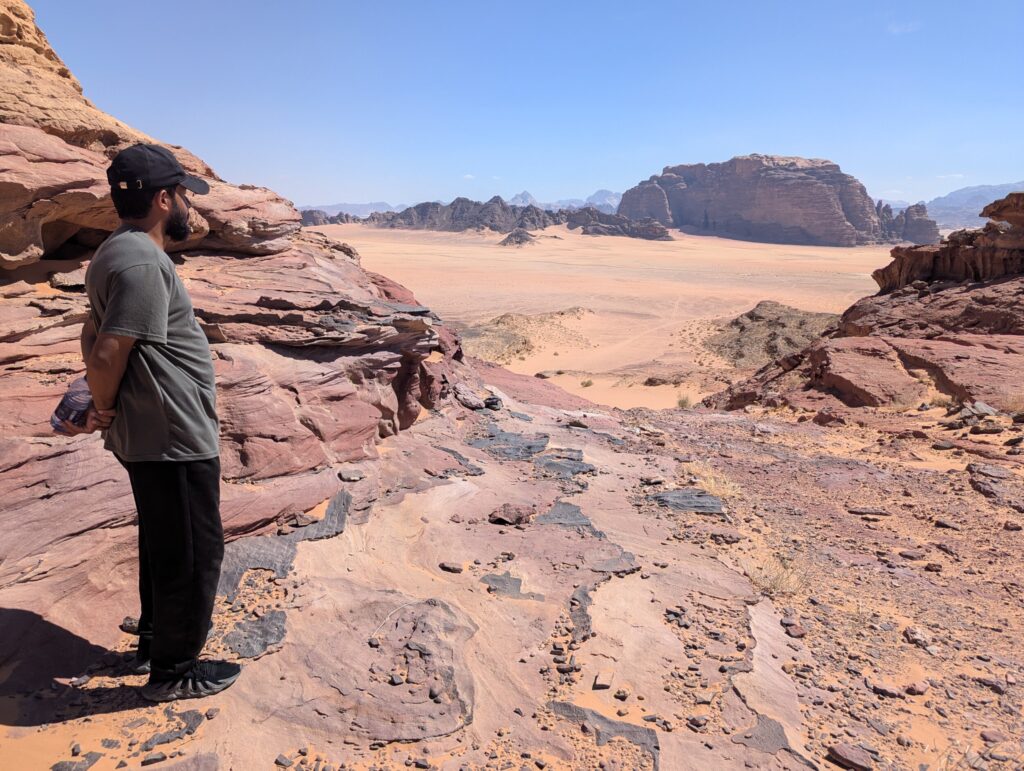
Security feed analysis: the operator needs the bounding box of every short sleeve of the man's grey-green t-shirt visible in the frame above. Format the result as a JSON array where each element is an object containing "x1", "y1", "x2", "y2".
[{"x1": 99, "y1": 265, "x2": 170, "y2": 343}]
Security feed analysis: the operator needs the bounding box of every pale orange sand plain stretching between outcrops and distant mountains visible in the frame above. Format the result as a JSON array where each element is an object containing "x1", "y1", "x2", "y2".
[{"x1": 310, "y1": 224, "x2": 891, "y2": 409}]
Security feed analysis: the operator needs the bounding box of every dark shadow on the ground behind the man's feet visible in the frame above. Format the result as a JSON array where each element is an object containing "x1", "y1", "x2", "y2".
[{"x1": 0, "y1": 607, "x2": 151, "y2": 726}]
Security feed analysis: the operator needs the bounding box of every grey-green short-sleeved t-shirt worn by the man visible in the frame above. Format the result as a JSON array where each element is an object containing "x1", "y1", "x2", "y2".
[{"x1": 85, "y1": 225, "x2": 219, "y2": 461}]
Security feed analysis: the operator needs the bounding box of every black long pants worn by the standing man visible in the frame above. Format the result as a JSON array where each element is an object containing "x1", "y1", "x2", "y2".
[{"x1": 122, "y1": 458, "x2": 224, "y2": 678}]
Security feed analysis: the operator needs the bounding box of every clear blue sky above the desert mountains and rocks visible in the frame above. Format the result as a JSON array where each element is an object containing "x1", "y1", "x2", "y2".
[{"x1": 30, "y1": 0, "x2": 1024, "y2": 205}]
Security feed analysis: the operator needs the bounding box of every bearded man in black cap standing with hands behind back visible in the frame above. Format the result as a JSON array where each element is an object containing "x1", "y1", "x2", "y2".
[{"x1": 65, "y1": 144, "x2": 241, "y2": 701}]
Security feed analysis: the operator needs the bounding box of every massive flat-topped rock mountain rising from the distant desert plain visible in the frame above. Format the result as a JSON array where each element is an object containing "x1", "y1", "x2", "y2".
[{"x1": 618, "y1": 155, "x2": 937, "y2": 246}]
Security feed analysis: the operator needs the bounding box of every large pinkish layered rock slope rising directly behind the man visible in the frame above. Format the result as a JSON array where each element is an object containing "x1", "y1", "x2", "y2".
[{"x1": 0, "y1": 0, "x2": 461, "y2": 659}]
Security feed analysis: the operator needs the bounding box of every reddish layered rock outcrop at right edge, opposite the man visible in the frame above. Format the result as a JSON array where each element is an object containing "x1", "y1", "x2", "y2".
[{"x1": 708, "y1": 194, "x2": 1024, "y2": 410}]
